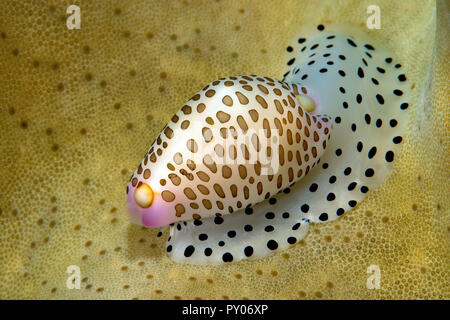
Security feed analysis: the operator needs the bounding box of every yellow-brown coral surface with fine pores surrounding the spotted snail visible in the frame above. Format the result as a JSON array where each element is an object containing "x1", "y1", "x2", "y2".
[{"x1": 0, "y1": 0, "x2": 450, "y2": 299}]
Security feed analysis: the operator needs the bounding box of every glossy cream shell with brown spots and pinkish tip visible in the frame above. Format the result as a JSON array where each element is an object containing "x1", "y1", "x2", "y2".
[{"x1": 128, "y1": 75, "x2": 331, "y2": 227}]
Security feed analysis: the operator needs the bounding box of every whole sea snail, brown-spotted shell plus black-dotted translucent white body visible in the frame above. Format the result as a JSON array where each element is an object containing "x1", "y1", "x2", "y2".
[{"x1": 127, "y1": 25, "x2": 409, "y2": 264}]
